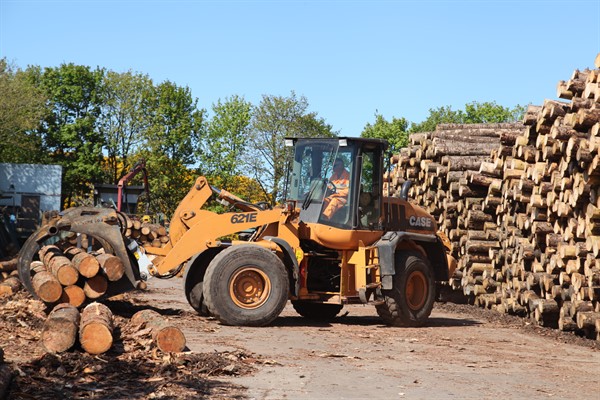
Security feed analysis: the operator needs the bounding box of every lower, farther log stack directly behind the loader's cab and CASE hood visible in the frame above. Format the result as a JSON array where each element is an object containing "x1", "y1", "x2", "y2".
[{"x1": 389, "y1": 123, "x2": 524, "y2": 288}]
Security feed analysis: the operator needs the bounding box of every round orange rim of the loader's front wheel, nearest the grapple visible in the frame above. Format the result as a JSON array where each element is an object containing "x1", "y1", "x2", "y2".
[{"x1": 229, "y1": 267, "x2": 271, "y2": 309}]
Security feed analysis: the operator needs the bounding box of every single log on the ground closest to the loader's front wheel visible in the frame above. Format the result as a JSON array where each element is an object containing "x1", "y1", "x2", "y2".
[{"x1": 131, "y1": 310, "x2": 185, "y2": 353}]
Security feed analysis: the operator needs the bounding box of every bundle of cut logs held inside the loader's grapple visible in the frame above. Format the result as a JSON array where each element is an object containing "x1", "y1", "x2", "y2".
[{"x1": 31, "y1": 245, "x2": 125, "y2": 307}]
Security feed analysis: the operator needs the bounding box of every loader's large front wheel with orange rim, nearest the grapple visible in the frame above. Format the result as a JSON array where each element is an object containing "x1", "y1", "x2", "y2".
[{"x1": 202, "y1": 245, "x2": 289, "y2": 326}]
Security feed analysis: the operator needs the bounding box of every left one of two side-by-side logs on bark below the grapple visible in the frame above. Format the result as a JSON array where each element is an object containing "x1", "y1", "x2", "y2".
[{"x1": 41, "y1": 303, "x2": 80, "y2": 353}]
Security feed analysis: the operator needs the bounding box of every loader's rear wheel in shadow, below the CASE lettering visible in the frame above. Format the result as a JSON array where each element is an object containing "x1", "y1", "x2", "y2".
[{"x1": 376, "y1": 252, "x2": 435, "y2": 326}]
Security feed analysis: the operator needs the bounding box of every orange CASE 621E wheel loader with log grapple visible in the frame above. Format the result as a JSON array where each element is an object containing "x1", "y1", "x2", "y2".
[{"x1": 18, "y1": 137, "x2": 456, "y2": 326}]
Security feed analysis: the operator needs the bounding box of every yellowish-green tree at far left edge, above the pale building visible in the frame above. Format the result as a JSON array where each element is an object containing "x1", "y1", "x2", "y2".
[{"x1": 0, "y1": 58, "x2": 47, "y2": 163}]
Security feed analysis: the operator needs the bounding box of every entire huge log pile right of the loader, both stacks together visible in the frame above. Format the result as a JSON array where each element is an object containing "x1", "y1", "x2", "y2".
[{"x1": 389, "y1": 54, "x2": 600, "y2": 339}]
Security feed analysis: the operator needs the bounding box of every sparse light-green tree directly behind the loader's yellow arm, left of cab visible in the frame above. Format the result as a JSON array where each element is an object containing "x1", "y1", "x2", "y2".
[{"x1": 199, "y1": 96, "x2": 252, "y2": 190}]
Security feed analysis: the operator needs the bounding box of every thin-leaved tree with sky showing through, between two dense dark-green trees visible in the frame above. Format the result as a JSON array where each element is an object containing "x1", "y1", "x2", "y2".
[{"x1": 97, "y1": 71, "x2": 154, "y2": 184}]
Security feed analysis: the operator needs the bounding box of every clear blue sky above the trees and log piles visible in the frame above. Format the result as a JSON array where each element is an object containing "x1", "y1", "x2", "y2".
[{"x1": 0, "y1": 0, "x2": 600, "y2": 136}]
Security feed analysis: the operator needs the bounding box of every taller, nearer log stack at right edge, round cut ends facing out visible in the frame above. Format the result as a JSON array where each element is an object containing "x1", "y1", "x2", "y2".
[{"x1": 475, "y1": 55, "x2": 600, "y2": 338}]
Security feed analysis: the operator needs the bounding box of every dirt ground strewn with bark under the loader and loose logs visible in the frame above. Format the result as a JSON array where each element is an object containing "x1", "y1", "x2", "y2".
[{"x1": 0, "y1": 278, "x2": 600, "y2": 399}]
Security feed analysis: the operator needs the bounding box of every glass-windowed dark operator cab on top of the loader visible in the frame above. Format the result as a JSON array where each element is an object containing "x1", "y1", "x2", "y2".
[{"x1": 286, "y1": 138, "x2": 387, "y2": 230}]
